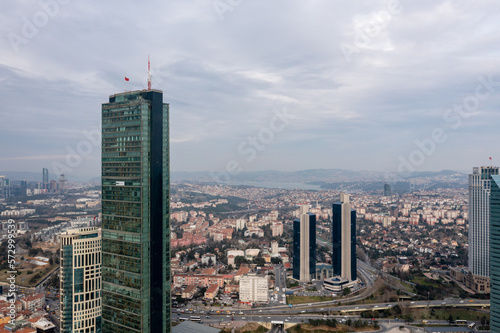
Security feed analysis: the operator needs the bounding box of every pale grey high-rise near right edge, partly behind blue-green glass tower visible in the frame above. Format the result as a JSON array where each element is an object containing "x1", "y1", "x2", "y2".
[{"x1": 469, "y1": 166, "x2": 498, "y2": 278}]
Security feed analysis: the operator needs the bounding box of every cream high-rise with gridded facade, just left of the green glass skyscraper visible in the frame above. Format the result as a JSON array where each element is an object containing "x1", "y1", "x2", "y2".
[{"x1": 60, "y1": 228, "x2": 102, "y2": 333}]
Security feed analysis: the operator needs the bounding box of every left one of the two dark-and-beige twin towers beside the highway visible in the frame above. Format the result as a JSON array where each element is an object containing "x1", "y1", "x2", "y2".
[{"x1": 293, "y1": 205, "x2": 316, "y2": 282}]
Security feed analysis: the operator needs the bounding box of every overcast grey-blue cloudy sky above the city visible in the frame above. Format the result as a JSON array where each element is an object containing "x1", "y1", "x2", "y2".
[{"x1": 0, "y1": 0, "x2": 500, "y2": 179}]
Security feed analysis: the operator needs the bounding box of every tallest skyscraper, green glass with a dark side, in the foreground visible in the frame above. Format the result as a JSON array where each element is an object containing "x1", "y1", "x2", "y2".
[{"x1": 102, "y1": 89, "x2": 171, "y2": 333}]
